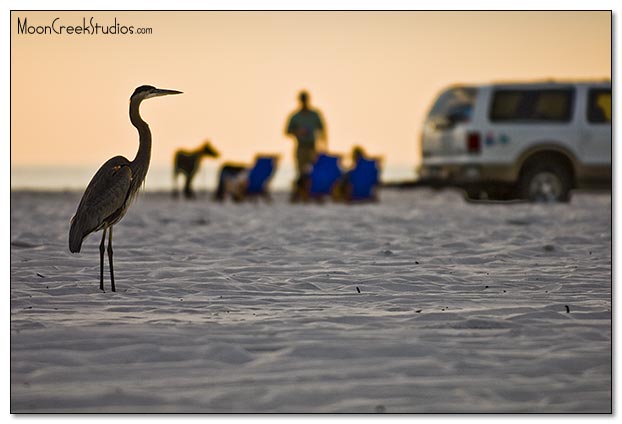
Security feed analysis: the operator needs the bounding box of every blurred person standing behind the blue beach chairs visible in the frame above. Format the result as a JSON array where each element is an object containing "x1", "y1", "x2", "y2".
[{"x1": 285, "y1": 91, "x2": 326, "y2": 200}]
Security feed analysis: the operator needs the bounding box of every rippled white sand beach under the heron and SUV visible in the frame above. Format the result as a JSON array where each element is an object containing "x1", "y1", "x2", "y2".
[{"x1": 10, "y1": 189, "x2": 612, "y2": 413}]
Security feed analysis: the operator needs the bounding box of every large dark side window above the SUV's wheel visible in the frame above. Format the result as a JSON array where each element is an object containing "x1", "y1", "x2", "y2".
[{"x1": 490, "y1": 89, "x2": 574, "y2": 123}]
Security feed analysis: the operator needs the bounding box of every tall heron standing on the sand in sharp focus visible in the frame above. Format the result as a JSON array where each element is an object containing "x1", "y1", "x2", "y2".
[{"x1": 69, "y1": 85, "x2": 181, "y2": 291}]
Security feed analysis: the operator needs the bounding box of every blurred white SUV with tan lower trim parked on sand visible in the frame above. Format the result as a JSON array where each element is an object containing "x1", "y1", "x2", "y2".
[{"x1": 419, "y1": 81, "x2": 611, "y2": 201}]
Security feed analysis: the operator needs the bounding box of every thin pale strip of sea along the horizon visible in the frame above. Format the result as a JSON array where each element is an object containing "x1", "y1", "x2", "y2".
[{"x1": 11, "y1": 164, "x2": 415, "y2": 191}]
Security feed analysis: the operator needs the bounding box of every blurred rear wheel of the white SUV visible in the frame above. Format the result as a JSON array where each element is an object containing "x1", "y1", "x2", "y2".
[{"x1": 518, "y1": 160, "x2": 572, "y2": 202}]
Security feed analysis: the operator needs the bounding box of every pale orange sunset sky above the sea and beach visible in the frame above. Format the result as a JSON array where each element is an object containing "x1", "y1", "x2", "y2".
[{"x1": 11, "y1": 11, "x2": 611, "y2": 179}]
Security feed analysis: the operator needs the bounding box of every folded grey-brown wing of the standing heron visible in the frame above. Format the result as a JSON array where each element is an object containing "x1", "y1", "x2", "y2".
[{"x1": 69, "y1": 156, "x2": 132, "y2": 251}]
